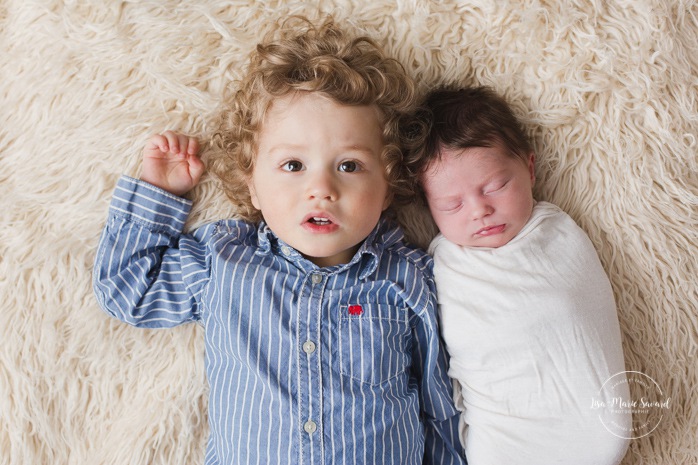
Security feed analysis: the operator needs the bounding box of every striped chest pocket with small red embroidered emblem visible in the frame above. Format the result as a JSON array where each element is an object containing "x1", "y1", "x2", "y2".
[{"x1": 339, "y1": 304, "x2": 412, "y2": 386}]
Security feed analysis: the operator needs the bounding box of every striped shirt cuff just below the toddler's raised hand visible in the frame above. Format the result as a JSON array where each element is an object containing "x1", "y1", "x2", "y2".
[{"x1": 109, "y1": 176, "x2": 192, "y2": 234}]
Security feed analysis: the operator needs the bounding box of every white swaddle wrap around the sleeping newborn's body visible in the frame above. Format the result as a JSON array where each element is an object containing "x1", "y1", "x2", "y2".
[{"x1": 430, "y1": 202, "x2": 631, "y2": 465}]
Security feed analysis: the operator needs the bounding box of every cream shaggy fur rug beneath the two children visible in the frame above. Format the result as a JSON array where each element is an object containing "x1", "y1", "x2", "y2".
[{"x1": 0, "y1": 0, "x2": 698, "y2": 465}]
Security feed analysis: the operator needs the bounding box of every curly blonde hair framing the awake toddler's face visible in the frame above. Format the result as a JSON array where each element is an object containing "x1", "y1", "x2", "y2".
[{"x1": 210, "y1": 16, "x2": 415, "y2": 223}]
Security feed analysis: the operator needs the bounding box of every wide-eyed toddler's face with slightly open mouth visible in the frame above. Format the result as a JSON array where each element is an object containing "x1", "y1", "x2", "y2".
[{"x1": 248, "y1": 92, "x2": 389, "y2": 266}]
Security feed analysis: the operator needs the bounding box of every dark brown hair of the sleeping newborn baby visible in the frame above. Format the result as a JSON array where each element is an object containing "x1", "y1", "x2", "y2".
[{"x1": 403, "y1": 86, "x2": 532, "y2": 181}]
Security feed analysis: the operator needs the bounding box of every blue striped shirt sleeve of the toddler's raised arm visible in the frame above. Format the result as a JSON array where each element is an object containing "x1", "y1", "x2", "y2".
[{"x1": 93, "y1": 176, "x2": 211, "y2": 328}]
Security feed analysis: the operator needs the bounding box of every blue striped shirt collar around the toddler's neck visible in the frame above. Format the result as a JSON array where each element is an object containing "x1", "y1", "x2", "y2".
[{"x1": 256, "y1": 218, "x2": 403, "y2": 279}]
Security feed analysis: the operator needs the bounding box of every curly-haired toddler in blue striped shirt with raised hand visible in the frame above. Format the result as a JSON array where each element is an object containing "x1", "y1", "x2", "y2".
[{"x1": 94, "y1": 18, "x2": 464, "y2": 465}]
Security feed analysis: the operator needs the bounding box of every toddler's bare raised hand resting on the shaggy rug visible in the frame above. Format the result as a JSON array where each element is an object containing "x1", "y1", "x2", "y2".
[{"x1": 141, "y1": 131, "x2": 204, "y2": 196}]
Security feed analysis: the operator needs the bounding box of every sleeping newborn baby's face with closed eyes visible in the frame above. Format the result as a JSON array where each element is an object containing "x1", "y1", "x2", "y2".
[{"x1": 421, "y1": 145, "x2": 535, "y2": 247}]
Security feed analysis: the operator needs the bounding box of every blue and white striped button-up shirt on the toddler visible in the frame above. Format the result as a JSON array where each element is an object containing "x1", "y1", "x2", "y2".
[{"x1": 94, "y1": 176, "x2": 464, "y2": 465}]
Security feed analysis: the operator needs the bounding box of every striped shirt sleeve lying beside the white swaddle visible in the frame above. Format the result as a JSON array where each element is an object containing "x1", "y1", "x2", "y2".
[{"x1": 412, "y1": 270, "x2": 467, "y2": 465}]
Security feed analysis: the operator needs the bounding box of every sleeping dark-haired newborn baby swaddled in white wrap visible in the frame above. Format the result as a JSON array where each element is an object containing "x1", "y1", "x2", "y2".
[{"x1": 411, "y1": 87, "x2": 630, "y2": 465}]
